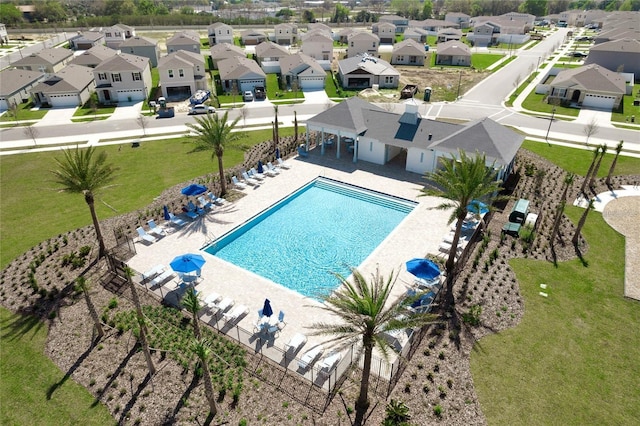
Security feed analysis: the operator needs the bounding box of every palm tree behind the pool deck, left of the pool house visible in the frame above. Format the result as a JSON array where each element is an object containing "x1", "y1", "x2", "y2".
[{"x1": 187, "y1": 111, "x2": 240, "y2": 195}]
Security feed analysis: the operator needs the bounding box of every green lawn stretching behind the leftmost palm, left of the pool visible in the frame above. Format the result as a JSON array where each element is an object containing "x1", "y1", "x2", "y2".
[{"x1": 0, "y1": 128, "x2": 293, "y2": 268}]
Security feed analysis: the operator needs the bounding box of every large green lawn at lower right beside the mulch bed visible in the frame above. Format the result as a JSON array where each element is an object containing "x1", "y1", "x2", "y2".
[{"x1": 471, "y1": 206, "x2": 640, "y2": 425}]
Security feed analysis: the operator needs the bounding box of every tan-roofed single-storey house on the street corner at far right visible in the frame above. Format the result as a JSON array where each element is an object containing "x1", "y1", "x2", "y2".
[{"x1": 547, "y1": 64, "x2": 626, "y2": 110}]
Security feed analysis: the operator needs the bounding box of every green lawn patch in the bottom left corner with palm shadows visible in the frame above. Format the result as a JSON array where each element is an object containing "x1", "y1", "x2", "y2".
[{"x1": 0, "y1": 308, "x2": 116, "y2": 426}]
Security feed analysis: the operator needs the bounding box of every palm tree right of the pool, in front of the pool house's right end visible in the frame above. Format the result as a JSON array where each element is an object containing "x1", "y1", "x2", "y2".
[{"x1": 421, "y1": 150, "x2": 504, "y2": 278}]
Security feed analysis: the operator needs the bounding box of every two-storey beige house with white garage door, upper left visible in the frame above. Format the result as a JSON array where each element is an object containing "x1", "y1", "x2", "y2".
[{"x1": 93, "y1": 53, "x2": 151, "y2": 104}]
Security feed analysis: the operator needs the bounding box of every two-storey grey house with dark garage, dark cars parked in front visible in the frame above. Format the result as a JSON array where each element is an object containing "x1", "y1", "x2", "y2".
[{"x1": 158, "y1": 50, "x2": 207, "y2": 100}]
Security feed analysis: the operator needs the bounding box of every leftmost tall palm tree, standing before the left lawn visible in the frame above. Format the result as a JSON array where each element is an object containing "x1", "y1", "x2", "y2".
[{"x1": 52, "y1": 147, "x2": 118, "y2": 257}]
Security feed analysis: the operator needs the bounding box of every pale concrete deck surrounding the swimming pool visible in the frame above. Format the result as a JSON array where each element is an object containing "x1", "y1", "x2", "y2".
[{"x1": 128, "y1": 150, "x2": 451, "y2": 380}]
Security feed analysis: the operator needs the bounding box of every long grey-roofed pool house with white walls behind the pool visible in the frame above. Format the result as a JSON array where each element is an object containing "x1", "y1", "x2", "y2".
[{"x1": 306, "y1": 97, "x2": 524, "y2": 181}]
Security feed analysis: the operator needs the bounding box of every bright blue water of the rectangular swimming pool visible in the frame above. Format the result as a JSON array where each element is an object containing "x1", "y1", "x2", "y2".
[{"x1": 205, "y1": 178, "x2": 417, "y2": 298}]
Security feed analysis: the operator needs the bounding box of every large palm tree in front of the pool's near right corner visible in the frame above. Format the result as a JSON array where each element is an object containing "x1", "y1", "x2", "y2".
[{"x1": 311, "y1": 268, "x2": 434, "y2": 426}]
